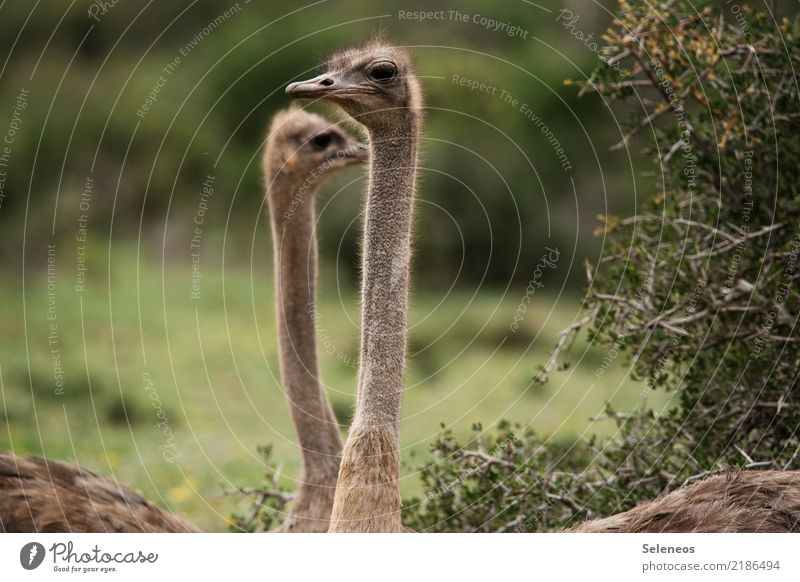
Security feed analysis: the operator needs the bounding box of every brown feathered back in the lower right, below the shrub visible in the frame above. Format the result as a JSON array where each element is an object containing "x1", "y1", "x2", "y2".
[{"x1": 569, "y1": 471, "x2": 800, "y2": 533}]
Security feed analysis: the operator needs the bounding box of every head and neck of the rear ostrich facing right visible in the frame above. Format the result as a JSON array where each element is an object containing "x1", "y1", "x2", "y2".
[{"x1": 262, "y1": 108, "x2": 368, "y2": 532}]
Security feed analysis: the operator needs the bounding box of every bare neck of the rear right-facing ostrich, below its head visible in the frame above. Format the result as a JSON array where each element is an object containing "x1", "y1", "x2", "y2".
[{"x1": 268, "y1": 174, "x2": 342, "y2": 485}]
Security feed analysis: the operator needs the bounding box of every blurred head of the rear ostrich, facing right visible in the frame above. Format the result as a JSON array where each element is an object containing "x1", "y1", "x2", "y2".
[{"x1": 263, "y1": 108, "x2": 369, "y2": 179}]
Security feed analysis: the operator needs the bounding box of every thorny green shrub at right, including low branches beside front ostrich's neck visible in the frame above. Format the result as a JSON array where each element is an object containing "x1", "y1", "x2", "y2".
[{"x1": 406, "y1": 0, "x2": 800, "y2": 531}]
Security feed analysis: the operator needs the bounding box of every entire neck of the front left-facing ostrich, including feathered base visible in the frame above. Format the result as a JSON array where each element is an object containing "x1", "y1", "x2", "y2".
[{"x1": 330, "y1": 112, "x2": 419, "y2": 532}]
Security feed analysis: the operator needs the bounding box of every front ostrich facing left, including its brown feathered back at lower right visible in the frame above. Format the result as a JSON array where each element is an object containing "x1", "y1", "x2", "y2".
[{"x1": 286, "y1": 42, "x2": 800, "y2": 532}]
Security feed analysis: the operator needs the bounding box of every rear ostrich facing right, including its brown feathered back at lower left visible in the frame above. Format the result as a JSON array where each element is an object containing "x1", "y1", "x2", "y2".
[{"x1": 0, "y1": 109, "x2": 367, "y2": 533}]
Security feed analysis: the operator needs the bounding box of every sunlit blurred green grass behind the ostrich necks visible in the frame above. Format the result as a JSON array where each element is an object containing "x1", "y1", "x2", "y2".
[{"x1": 0, "y1": 245, "x2": 663, "y2": 530}]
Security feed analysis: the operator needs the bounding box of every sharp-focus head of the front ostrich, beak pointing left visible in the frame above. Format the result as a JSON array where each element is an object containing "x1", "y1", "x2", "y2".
[{"x1": 286, "y1": 41, "x2": 422, "y2": 129}]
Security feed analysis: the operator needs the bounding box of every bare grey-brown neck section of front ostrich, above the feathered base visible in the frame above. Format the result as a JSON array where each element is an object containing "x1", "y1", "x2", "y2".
[{"x1": 355, "y1": 119, "x2": 419, "y2": 431}]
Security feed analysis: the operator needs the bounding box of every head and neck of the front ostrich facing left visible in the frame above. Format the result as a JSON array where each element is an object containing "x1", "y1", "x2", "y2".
[{"x1": 286, "y1": 43, "x2": 422, "y2": 532}]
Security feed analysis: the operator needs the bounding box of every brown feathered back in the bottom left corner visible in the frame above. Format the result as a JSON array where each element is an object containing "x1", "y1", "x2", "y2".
[{"x1": 0, "y1": 452, "x2": 199, "y2": 533}]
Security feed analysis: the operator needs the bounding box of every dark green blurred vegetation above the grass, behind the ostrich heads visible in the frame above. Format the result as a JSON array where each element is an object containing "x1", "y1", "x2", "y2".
[{"x1": 0, "y1": 0, "x2": 635, "y2": 287}]
